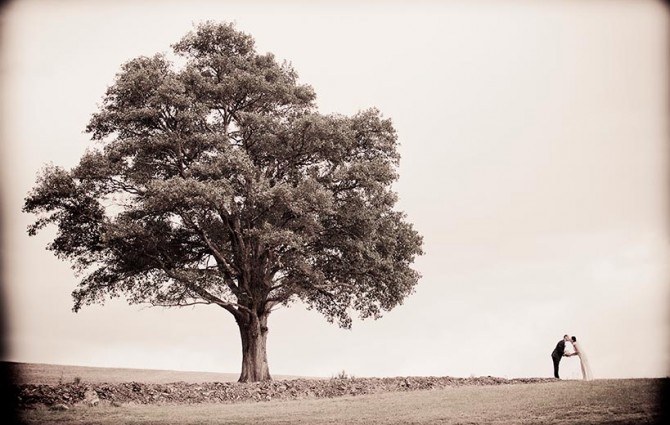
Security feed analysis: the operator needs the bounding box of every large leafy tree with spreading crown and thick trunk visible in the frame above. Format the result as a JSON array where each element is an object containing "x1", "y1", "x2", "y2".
[{"x1": 24, "y1": 22, "x2": 422, "y2": 381}]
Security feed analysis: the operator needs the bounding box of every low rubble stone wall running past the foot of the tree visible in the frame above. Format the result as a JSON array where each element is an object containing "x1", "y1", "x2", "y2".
[{"x1": 15, "y1": 377, "x2": 554, "y2": 409}]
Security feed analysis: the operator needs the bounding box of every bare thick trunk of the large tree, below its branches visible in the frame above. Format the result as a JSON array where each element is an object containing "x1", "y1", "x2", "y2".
[{"x1": 237, "y1": 314, "x2": 272, "y2": 382}]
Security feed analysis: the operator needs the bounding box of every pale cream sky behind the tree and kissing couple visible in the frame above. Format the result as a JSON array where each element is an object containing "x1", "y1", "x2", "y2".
[{"x1": 0, "y1": 0, "x2": 670, "y2": 378}]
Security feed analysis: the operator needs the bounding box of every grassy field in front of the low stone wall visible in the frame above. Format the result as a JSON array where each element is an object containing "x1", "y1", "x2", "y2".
[{"x1": 15, "y1": 379, "x2": 663, "y2": 425}]
